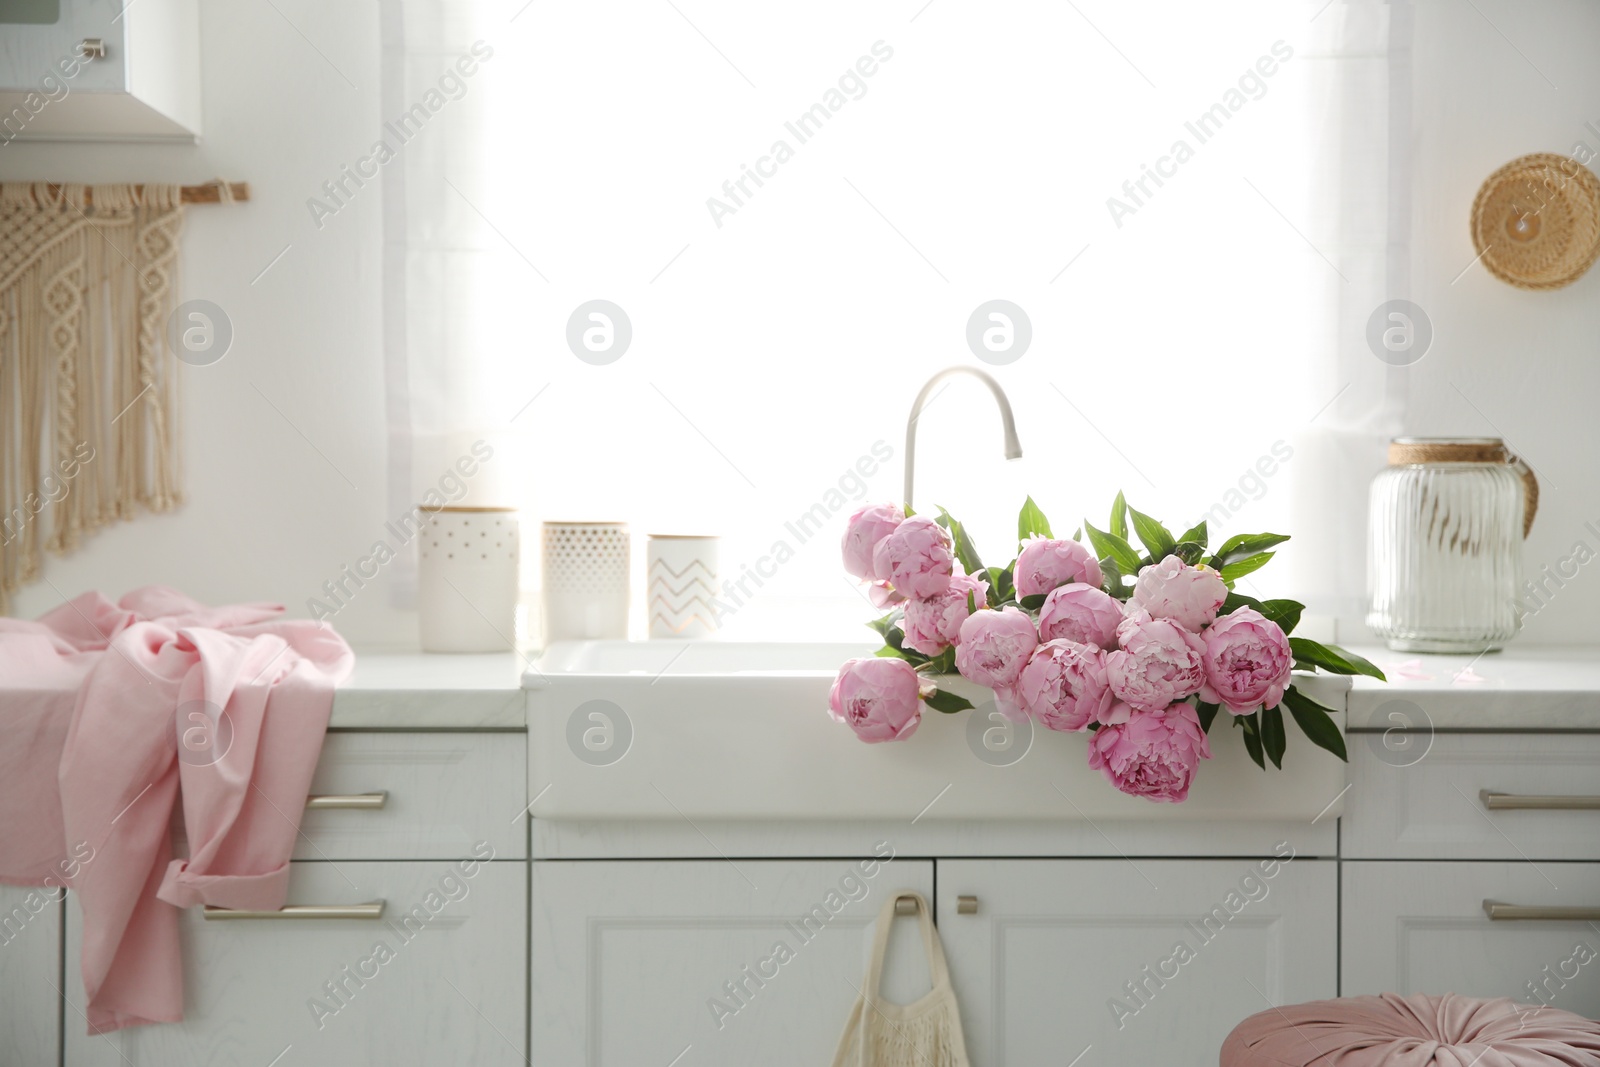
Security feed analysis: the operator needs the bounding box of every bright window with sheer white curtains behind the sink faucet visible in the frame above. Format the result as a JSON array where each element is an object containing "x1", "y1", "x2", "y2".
[{"x1": 384, "y1": 0, "x2": 1392, "y2": 637}]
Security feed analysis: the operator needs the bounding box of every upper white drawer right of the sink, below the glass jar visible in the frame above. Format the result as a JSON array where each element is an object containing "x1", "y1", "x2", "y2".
[{"x1": 1342, "y1": 733, "x2": 1600, "y2": 859}]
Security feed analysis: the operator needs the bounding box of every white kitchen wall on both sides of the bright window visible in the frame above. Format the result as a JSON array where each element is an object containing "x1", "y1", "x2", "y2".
[{"x1": 0, "y1": 0, "x2": 1600, "y2": 648}]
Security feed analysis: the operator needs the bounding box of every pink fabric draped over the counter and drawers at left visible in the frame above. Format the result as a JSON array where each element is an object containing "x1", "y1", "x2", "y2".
[{"x1": 0, "y1": 587, "x2": 354, "y2": 1033}]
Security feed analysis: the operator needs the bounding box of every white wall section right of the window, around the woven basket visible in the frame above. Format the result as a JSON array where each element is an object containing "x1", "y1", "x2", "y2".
[{"x1": 1406, "y1": 0, "x2": 1600, "y2": 641}]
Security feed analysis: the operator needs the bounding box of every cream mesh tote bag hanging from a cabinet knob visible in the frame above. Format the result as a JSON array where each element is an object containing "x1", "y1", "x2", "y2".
[{"x1": 834, "y1": 891, "x2": 968, "y2": 1067}]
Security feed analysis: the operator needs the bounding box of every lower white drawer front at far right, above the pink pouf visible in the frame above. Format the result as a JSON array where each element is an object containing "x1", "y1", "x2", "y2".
[{"x1": 1342, "y1": 862, "x2": 1600, "y2": 1019}]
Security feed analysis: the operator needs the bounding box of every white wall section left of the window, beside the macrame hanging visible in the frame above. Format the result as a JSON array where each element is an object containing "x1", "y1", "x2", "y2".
[{"x1": 0, "y1": 0, "x2": 416, "y2": 646}]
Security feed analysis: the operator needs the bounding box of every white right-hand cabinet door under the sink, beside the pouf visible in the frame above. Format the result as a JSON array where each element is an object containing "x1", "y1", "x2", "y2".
[{"x1": 938, "y1": 849, "x2": 1338, "y2": 1067}]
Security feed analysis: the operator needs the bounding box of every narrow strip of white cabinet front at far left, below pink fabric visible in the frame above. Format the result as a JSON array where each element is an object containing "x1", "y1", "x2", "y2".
[{"x1": 0, "y1": 886, "x2": 62, "y2": 1064}]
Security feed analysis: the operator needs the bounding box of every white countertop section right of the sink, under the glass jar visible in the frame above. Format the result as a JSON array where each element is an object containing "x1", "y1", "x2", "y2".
[{"x1": 1347, "y1": 641, "x2": 1600, "y2": 731}]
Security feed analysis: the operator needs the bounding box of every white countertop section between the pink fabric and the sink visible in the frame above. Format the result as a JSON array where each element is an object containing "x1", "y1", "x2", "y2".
[{"x1": 328, "y1": 653, "x2": 528, "y2": 729}]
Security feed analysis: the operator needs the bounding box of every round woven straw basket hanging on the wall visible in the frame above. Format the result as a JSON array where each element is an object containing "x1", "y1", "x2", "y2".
[{"x1": 1472, "y1": 152, "x2": 1600, "y2": 290}]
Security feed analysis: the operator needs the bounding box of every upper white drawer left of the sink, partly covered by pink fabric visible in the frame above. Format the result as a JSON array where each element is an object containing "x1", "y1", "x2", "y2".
[{"x1": 178, "y1": 731, "x2": 528, "y2": 861}]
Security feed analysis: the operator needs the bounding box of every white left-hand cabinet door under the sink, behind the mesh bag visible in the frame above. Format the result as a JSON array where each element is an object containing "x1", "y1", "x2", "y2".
[{"x1": 531, "y1": 859, "x2": 933, "y2": 1067}]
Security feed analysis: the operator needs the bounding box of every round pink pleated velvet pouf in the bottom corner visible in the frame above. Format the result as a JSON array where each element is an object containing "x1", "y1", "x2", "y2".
[{"x1": 1222, "y1": 993, "x2": 1600, "y2": 1067}]
